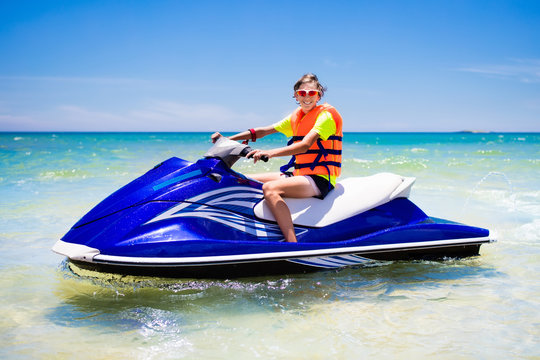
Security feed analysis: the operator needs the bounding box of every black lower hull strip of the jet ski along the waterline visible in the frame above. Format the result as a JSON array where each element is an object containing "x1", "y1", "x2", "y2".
[{"x1": 64, "y1": 239, "x2": 491, "y2": 279}]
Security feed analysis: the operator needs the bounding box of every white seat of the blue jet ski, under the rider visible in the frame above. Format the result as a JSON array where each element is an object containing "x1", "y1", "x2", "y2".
[{"x1": 254, "y1": 173, "x2": 416, "y2": 227}]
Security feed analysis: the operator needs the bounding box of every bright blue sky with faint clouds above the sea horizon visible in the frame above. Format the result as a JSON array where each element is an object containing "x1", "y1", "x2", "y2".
[{"x1": 0, "y1": 0, "x2": 540, "y2": 131}]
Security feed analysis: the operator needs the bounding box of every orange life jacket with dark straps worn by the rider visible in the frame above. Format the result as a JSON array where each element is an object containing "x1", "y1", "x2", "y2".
[{"x1": 280, "y1": 104, "x2": 343, "y2": 177}]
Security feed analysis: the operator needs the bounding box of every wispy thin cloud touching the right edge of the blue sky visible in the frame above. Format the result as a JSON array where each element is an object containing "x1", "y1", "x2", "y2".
[{"x1": 459, "y1": 59, "x2": 540, "y2": 83}]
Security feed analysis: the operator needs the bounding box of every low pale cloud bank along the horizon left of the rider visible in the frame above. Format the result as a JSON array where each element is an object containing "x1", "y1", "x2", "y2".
[{"x1": 0, "y1": 101, "x2": 265, "y2": 131}]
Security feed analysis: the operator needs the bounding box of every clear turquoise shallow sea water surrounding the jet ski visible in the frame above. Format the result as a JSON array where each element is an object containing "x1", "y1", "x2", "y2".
[{"x1": 0, "y1": 133, "x2": 540, "y2": 359}]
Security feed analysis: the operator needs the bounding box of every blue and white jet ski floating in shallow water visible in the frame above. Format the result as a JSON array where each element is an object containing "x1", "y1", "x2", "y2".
[{"x1": 52, "y1": 137, "x2": 494, "y2": 278}]
